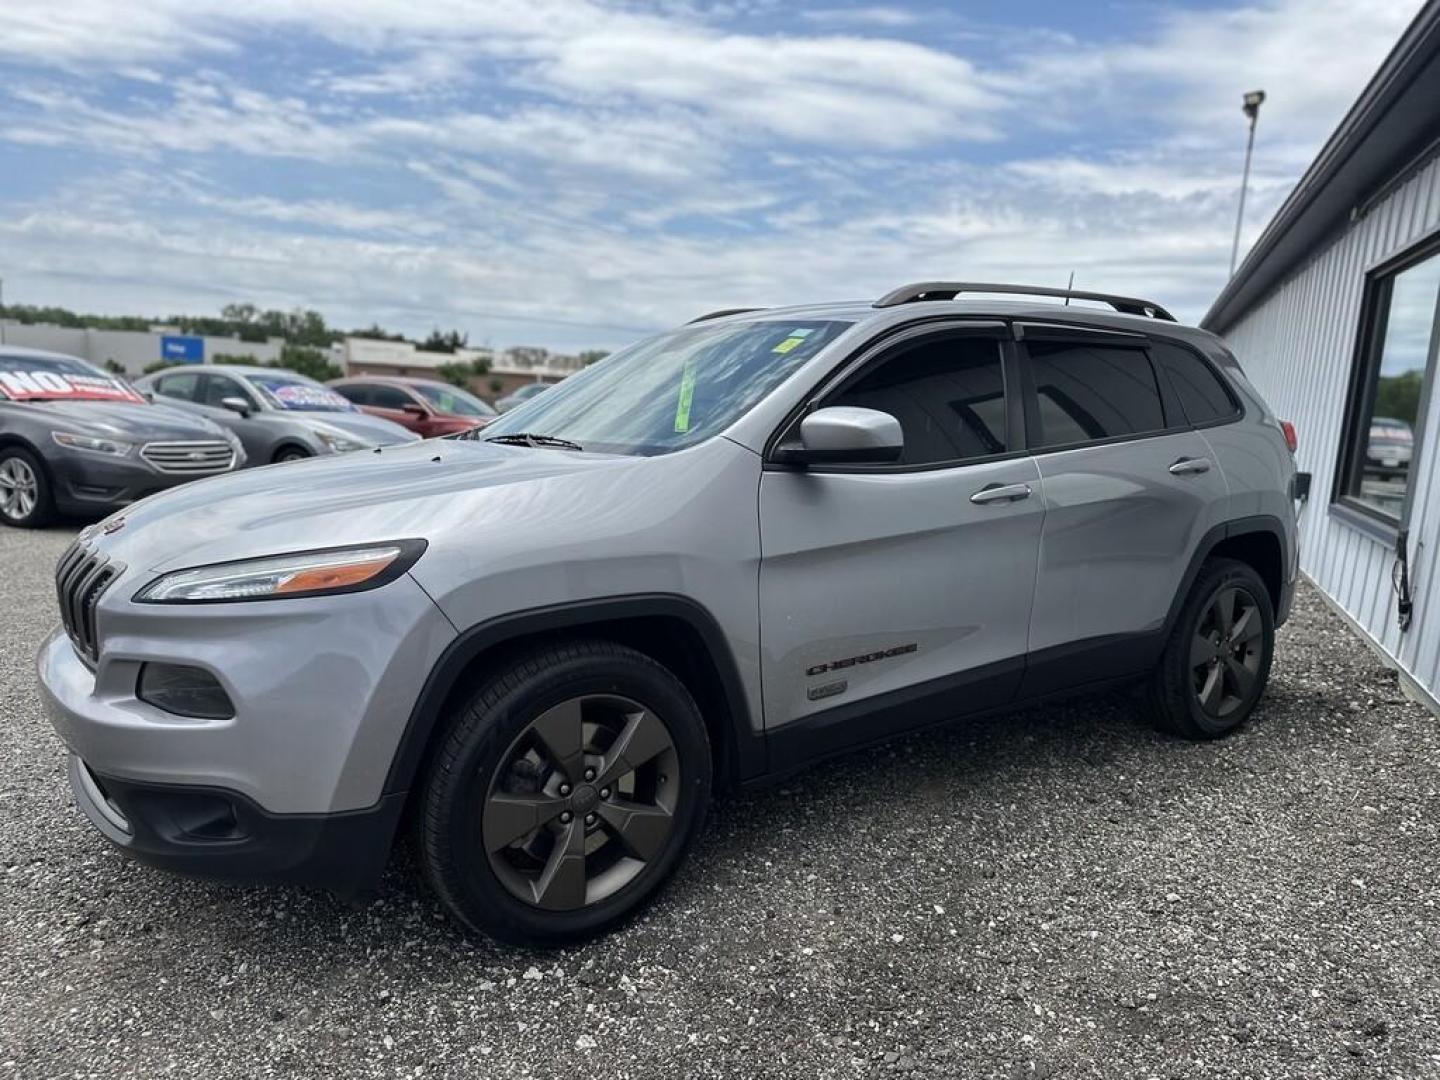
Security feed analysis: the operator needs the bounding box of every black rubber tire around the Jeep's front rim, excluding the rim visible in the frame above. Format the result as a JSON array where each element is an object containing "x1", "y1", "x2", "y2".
[{"x1": 429, "y1": 654, "x2": 710, "y2": 942}]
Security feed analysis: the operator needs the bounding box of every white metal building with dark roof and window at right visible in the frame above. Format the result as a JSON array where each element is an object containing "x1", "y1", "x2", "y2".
[{"x1": 1202, "y1": 0, "x2": 1440, "y2": 704}]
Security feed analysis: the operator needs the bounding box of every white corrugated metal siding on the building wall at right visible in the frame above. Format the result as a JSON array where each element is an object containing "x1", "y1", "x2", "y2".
[{"x1": 1225, "y1": 158, "x2": 1440, "y2": 696}]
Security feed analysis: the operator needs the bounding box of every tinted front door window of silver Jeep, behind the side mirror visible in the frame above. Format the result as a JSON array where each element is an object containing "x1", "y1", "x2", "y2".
[{"x1": 827, "y1": 337, "x2": 1007, "y2": 465}]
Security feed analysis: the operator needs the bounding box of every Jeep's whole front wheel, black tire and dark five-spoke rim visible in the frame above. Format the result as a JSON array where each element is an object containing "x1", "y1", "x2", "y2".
[{"x1": 416, "y1": 639, "x2": 711, "y2": 945}]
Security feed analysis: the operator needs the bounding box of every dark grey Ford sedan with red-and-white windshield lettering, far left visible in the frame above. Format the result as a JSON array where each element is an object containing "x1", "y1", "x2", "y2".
[{"x1": 0, "y1": 346, "x2": 245, "y2": 528}]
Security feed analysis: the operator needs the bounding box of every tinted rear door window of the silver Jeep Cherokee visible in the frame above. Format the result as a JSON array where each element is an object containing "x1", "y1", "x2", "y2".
[{"x1": 1027, "y1": 341, "x2": 1165, "y2": 446}]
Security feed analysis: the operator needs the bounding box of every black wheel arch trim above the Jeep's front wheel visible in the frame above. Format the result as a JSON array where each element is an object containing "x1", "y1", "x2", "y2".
[{"x1": 384, "y1": 593, "x2": 766, "y2": 795}]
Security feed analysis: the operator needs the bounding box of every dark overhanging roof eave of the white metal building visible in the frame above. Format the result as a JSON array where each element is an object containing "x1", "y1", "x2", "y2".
[{"x1": 1201, "y1": 0, "x2": 1440, "y2": 334}]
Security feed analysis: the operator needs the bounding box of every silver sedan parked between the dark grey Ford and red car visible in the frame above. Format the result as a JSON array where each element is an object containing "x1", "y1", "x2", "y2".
[{"x1": 135, "y1": 364, "x2": 419, "y2": 465}]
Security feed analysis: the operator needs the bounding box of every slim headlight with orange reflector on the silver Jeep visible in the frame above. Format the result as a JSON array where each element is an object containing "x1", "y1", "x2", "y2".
[{"x1": 135, "y1": 540, "x2": 425, "y2": 603}]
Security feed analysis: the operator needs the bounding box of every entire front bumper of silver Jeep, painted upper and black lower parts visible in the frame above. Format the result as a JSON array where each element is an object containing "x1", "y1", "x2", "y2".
[{"x1": 36, "y1": 570, "x2": 455, "y2": 891}]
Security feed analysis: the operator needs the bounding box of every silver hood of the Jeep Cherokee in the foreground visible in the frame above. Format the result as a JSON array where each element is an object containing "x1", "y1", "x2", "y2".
[{"x1": 95, "y1": 439, "x2": 664, "y2": 570}]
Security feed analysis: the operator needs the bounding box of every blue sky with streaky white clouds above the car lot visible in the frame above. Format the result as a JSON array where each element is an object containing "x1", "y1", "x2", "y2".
[{"x1": 0, "y1": 0, "x2": 1418, "y2": 350}]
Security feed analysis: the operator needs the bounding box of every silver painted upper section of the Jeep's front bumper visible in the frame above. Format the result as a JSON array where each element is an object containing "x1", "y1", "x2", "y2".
[{"x1": 36, "y1": 570, "x2": 455, "y2": 814}]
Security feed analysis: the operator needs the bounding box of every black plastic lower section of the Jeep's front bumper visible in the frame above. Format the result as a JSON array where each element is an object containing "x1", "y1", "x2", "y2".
[{"x1": 69, "y1": 755, "x2": 405, "y2": 894}]
